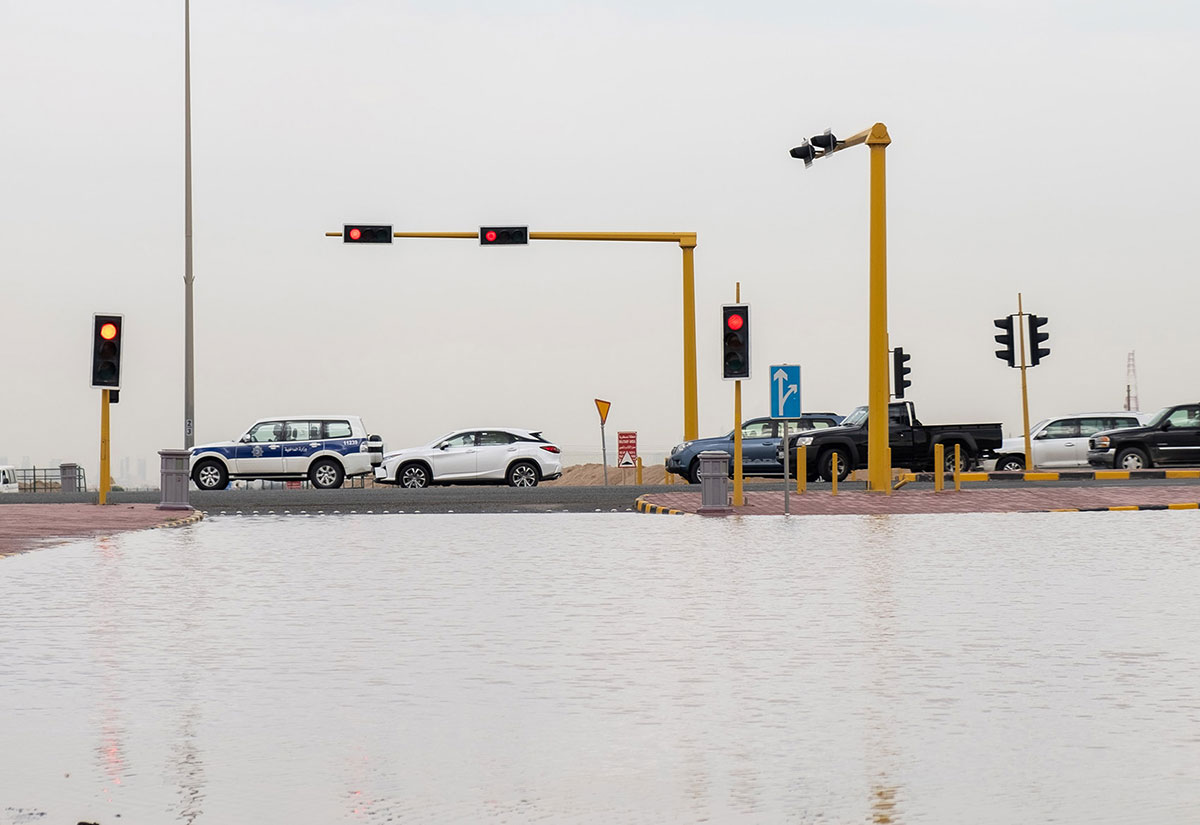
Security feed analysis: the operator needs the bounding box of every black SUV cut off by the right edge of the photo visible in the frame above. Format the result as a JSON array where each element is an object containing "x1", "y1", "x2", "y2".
[{"x1": 1087, "y1": 403, "x2": 1200, "y2": 470}]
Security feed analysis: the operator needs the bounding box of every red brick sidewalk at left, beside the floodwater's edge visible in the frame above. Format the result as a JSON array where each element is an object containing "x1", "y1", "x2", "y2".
[{"x1": 0, "y1": 504, "x2": 196, "y2": 556}]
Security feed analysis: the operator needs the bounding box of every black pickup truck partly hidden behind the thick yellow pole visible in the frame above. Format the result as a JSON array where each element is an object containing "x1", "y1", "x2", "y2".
[{"x1": 779, "y1": 401, "x2": 1004, "y2": 481}]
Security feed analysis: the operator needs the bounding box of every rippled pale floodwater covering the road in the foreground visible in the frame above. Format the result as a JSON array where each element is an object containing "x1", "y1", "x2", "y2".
[{"x1": 0, "y1": 511, "x2": 1200, "y2": 825}]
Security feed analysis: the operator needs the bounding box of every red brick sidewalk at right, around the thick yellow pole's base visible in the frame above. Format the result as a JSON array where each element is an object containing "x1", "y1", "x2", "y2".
[{"x1": 641, "y1": 484, "x2": 1200, "y2": 516}]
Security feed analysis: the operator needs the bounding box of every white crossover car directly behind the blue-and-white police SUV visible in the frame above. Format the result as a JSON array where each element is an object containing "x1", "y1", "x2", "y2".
[{"x1": 374, "y1": 427, "x2": 563, "y2": 488}]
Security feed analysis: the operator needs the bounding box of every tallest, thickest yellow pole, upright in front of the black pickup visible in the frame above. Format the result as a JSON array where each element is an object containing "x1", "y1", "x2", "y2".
[{"x1": 866, "y1": 124, "x2": 892, "y2": 494}]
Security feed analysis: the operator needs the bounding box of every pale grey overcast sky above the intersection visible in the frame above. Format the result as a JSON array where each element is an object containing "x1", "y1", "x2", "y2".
[{"x1": 0, "y1": 0, "x2": 1200, "y2": 483}]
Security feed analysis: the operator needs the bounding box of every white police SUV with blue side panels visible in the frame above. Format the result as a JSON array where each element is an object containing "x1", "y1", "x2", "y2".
[{"x1": 191, "y1": 415, "x2": 383, "y2": 490}]
